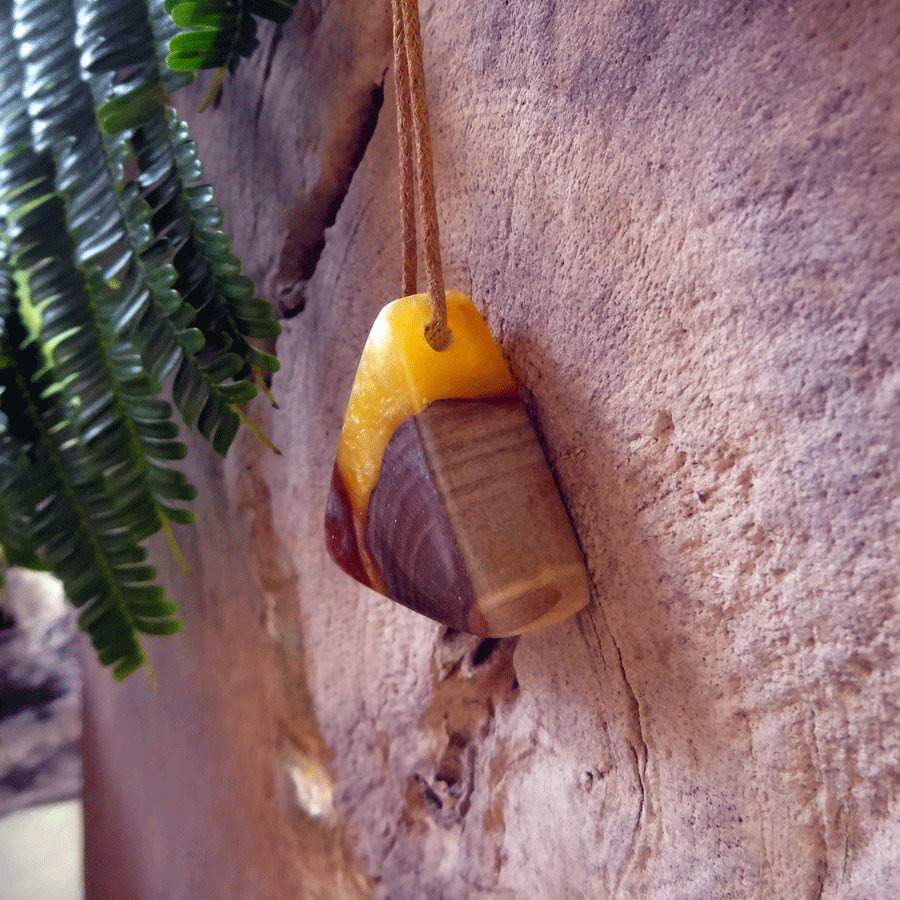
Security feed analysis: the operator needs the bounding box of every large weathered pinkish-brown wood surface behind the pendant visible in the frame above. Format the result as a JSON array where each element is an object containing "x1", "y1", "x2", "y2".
[{"x1": 82, "y1": 0, "x2": 900, "y2": 900}]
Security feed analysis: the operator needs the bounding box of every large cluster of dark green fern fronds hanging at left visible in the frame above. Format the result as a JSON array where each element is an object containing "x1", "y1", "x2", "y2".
[{"x1": 0, "y1": 0, "x2": 282, "y2": 678}]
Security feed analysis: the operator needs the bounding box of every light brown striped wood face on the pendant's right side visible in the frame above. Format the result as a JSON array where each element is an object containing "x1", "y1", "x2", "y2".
[{"x1": 416, "y1": 398, "x2": 588, "y2": 637}]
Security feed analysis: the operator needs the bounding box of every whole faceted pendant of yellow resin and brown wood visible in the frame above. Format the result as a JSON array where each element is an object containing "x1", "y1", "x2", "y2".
[{"x1": 325, "y1": 291, "x2": 589, "y2": 637}]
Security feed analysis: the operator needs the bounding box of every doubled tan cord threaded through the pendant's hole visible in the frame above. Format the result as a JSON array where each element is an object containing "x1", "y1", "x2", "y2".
[{"x1": 392, "y1": 0, "x2": 452, "y2": 350}]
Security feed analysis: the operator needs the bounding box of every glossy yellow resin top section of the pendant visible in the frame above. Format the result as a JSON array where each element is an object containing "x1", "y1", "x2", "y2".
[{"x1": 337, "y1": 291, "x2": 518, "y2": 523}]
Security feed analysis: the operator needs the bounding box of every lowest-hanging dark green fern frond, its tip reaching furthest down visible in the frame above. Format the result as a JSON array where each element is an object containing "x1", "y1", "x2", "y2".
[{"x1": 0, "y1": 243, "x2": 179, "y2": 680}]
